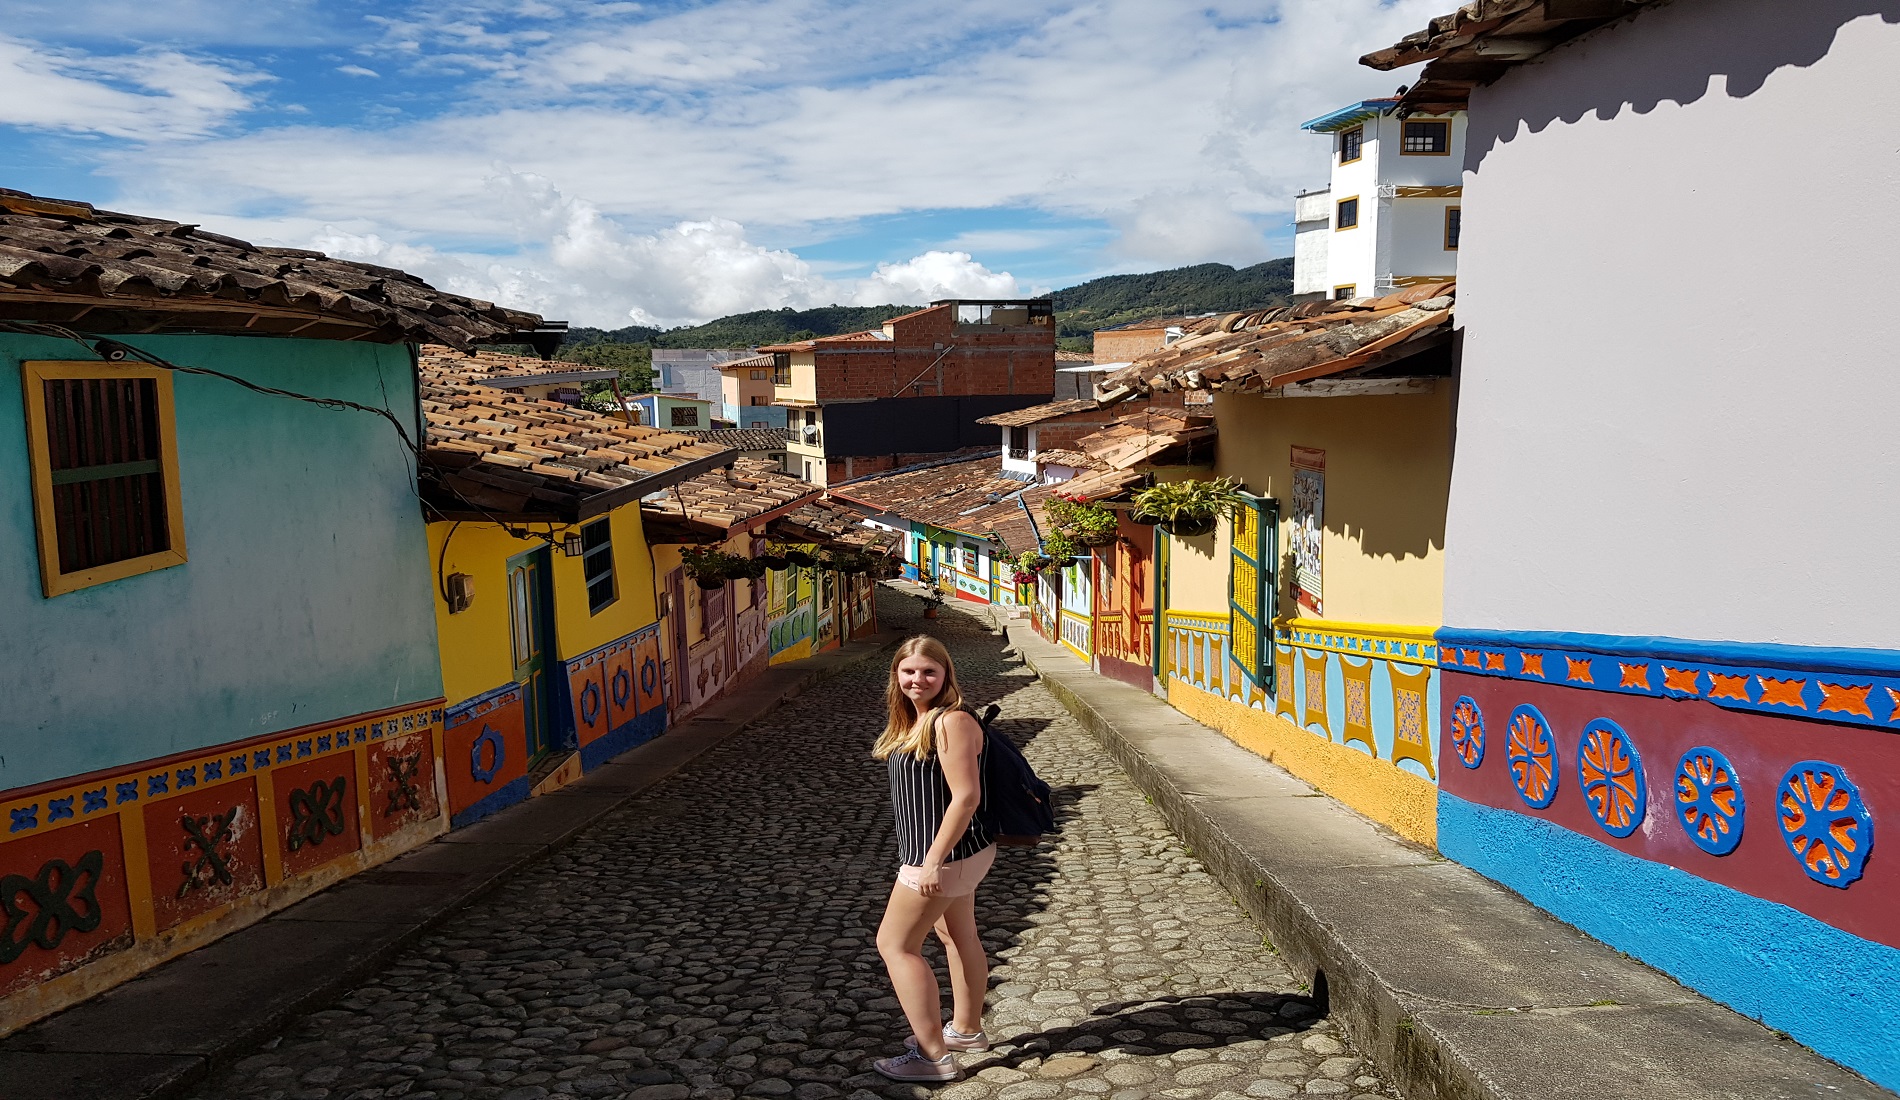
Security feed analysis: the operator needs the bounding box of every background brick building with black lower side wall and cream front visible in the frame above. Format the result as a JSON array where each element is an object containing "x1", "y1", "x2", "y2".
[{"x1": 760, "y1": 298, "x2": 1056, "y2": 484}]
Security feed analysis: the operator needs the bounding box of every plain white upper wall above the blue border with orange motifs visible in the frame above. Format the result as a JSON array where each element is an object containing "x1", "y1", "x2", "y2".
[{"x1": 1446, "y1": 0, "x2": 1900, "y2": 648}]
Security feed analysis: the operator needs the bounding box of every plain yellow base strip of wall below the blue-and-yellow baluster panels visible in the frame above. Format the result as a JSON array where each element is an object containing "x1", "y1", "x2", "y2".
[{"x1": 1169, "y1": 676, "x2": 1438, "y2": 847}]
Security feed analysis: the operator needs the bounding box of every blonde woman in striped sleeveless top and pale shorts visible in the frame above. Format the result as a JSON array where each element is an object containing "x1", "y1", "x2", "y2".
[{"x1": 872, "y1": 635, "x2": 996, "y2": 1081}]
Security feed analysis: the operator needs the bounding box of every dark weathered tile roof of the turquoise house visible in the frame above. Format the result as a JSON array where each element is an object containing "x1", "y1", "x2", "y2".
[{"x1": 0, "y1": 188, "x2": 542, "y2": 348}]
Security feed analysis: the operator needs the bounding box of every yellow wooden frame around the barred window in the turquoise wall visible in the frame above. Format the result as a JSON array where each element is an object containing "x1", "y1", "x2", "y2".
[{"x1": 21, "y1": 359, "x2": 186, "y2": 598}]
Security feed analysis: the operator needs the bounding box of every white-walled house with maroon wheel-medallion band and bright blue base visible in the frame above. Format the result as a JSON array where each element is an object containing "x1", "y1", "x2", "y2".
[{"x1": 1368, "y1": 0, "x2": 1900, "y2": 1089}]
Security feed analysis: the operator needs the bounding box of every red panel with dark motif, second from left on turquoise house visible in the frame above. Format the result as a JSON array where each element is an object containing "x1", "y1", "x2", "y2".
[{"x1": 144, "y1": 779, "x2": 264, "y2": 931}]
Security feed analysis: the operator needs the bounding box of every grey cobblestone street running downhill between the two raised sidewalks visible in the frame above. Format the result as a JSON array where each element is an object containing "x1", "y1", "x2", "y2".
[{"x1": 196, "y1": 591, "x2": 1393, "y2": 1100}]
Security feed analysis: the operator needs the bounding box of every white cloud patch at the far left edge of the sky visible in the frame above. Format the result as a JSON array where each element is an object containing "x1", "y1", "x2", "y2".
[{"x1": 0, "y1": 36, "x2": 266, "y2": 141}]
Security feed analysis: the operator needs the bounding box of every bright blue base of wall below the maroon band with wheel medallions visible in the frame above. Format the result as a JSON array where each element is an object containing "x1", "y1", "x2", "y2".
[{"x1": 1438, "y1": 792, "x2": 1900, "y2": 1091}]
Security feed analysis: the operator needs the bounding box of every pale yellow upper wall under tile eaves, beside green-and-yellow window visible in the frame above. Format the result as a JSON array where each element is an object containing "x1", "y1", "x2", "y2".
[{"x1": 1216, "y1": 380, "x2": 1454, "y2": 627}]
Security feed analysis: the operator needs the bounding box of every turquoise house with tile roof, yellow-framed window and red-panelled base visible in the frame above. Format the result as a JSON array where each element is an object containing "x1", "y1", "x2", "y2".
[{"x1": 0, "y1": 192, "x2": 538, "y2": 1032}]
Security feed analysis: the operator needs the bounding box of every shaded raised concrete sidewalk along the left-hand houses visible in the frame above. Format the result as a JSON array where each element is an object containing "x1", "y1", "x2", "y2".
[{"x1": 0, "y1": 631, "x2": 903, "y2": 1100}]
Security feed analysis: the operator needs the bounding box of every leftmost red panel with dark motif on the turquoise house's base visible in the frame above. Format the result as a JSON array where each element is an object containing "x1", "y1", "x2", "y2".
[{"x1": 0, "y1": 813, "x2": 131, "y2": 996}]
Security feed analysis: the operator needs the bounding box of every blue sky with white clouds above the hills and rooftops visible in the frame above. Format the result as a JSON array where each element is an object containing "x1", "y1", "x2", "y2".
[{"x1": 0, "y1": 0, "x2": 1450, "y2": 325}]
